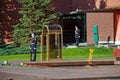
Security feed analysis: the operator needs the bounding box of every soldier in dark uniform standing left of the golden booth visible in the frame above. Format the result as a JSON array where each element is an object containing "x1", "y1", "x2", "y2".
[{"x1": 30, "y1": 32, "x2": 37, "y2": 61}]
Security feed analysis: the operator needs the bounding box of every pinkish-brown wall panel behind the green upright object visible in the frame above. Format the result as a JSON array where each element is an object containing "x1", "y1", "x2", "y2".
[{"x1": 87, "y1": 12, "x2": 114, "y2": 43}]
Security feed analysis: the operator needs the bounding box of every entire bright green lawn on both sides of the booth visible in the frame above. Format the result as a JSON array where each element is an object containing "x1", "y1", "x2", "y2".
[{"x1": 0, "y1": 47, "x2": 113, "y2": 61}]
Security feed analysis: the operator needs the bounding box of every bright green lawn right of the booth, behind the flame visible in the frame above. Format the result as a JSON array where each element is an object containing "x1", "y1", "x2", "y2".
[{"x1": 63, "y1": 47, "x2": 113, "y2": 59}]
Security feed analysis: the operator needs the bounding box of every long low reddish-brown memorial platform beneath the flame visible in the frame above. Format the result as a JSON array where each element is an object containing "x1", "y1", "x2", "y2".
[{"x1": 23, "y1": 59, "x2": 114, "y2": 67}]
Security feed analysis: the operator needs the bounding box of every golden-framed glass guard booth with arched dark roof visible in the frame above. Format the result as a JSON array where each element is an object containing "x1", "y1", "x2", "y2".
[{"x1": 41, "y1": 25, "x2": 63, "y2": 61}]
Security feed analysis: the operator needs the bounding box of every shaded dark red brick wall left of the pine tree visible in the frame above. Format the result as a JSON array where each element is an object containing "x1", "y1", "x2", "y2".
[{"x1": 0, "y1": 0, "x2": 21, "y2": 44}]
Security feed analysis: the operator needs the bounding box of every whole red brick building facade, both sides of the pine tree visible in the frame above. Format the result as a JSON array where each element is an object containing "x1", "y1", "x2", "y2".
[{"x1": 0, "y1": 0, "x2": 120, "y2": 44}]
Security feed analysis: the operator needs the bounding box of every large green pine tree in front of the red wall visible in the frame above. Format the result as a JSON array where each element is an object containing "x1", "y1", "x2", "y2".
[{"x1": 14, "y1": 0, "x2": 57, "y2": 46}]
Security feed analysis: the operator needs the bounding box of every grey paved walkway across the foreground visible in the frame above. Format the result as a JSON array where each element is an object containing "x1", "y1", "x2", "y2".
[{"x1": 0, "y1": 65, "x2": 120, "y2": 80}]
